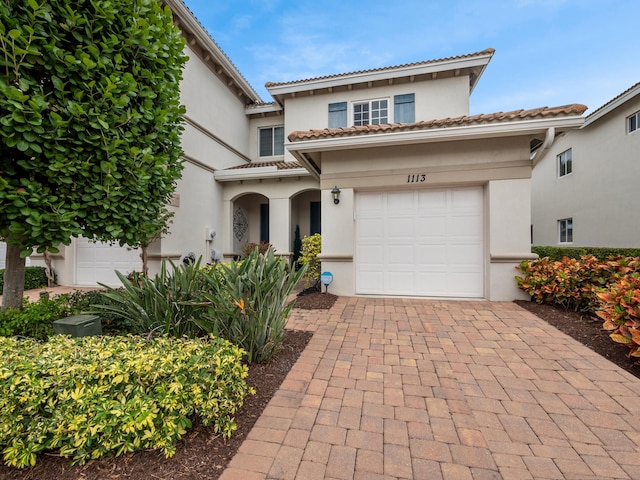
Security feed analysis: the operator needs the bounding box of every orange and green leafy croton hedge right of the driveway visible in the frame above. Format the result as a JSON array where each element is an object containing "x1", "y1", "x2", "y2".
[{"x1": 516, "y1": 255, "x2": 640, "y2": 357}]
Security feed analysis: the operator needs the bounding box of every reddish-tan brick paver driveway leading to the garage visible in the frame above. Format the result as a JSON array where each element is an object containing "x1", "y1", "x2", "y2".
[{"x1": 221, "y1": 297, "x2": 640, "y2": 480}]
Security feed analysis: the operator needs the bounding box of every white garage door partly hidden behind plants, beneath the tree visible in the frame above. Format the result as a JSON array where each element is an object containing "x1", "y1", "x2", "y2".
[{"x1": 76, "y1": 238, "x2": 142, "y2": 286}]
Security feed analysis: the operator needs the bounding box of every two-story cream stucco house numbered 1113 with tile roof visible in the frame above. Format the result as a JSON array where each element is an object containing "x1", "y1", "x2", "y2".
[{"x1": 18, "y1": 0, "x2": 586, "y2": 300}]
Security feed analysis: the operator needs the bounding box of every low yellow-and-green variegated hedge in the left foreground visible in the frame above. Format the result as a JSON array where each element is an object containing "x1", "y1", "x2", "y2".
[{"x1": 0, "y1": 335, "x2": 252, "y2": 468}]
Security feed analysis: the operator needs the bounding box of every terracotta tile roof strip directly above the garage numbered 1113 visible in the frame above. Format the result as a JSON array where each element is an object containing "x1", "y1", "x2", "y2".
[{"x1": 288, "y1": 103, "x2": 587, "y2": 142}]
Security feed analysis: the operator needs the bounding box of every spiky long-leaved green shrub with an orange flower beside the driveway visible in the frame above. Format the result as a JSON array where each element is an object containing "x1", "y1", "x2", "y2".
[{"x1": 195, "y1": 249, "x2": 305, "y2": 363}]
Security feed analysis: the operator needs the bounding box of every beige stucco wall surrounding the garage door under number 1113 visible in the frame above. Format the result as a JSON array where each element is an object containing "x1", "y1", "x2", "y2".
[{"x1": 321, "y1": 137, "x2": 531, "y2": 300}]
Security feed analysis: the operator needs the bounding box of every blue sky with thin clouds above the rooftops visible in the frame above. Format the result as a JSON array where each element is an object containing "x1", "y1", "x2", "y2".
[{"x1": 185, "y1": 0, "x2": 640, "y2": 114}]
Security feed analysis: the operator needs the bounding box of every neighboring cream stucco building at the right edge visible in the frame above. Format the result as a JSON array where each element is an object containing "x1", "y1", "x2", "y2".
[{"x1": 531, "y1": 83, "x2": 640, "y2": 248}]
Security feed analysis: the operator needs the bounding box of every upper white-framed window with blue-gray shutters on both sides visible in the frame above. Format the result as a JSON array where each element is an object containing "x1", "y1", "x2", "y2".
[{"x1": 328, "y1": 93, "x2": 415, "y2": 128}]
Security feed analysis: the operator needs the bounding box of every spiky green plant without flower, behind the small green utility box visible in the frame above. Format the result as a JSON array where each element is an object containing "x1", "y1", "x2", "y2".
[{"x1": 93, "y1": 259, "x2": 206, "y2": 337}]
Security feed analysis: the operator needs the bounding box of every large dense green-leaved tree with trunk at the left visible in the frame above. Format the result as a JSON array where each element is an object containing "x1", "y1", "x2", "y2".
[{"x1": 0, "y1": 0, "x2": 186, "y2": 308}]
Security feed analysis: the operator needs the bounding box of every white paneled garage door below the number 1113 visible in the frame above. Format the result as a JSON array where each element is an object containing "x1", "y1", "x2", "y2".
[{"x1": 355, "y1": 187, "x2": 484, "y2": 297}]
